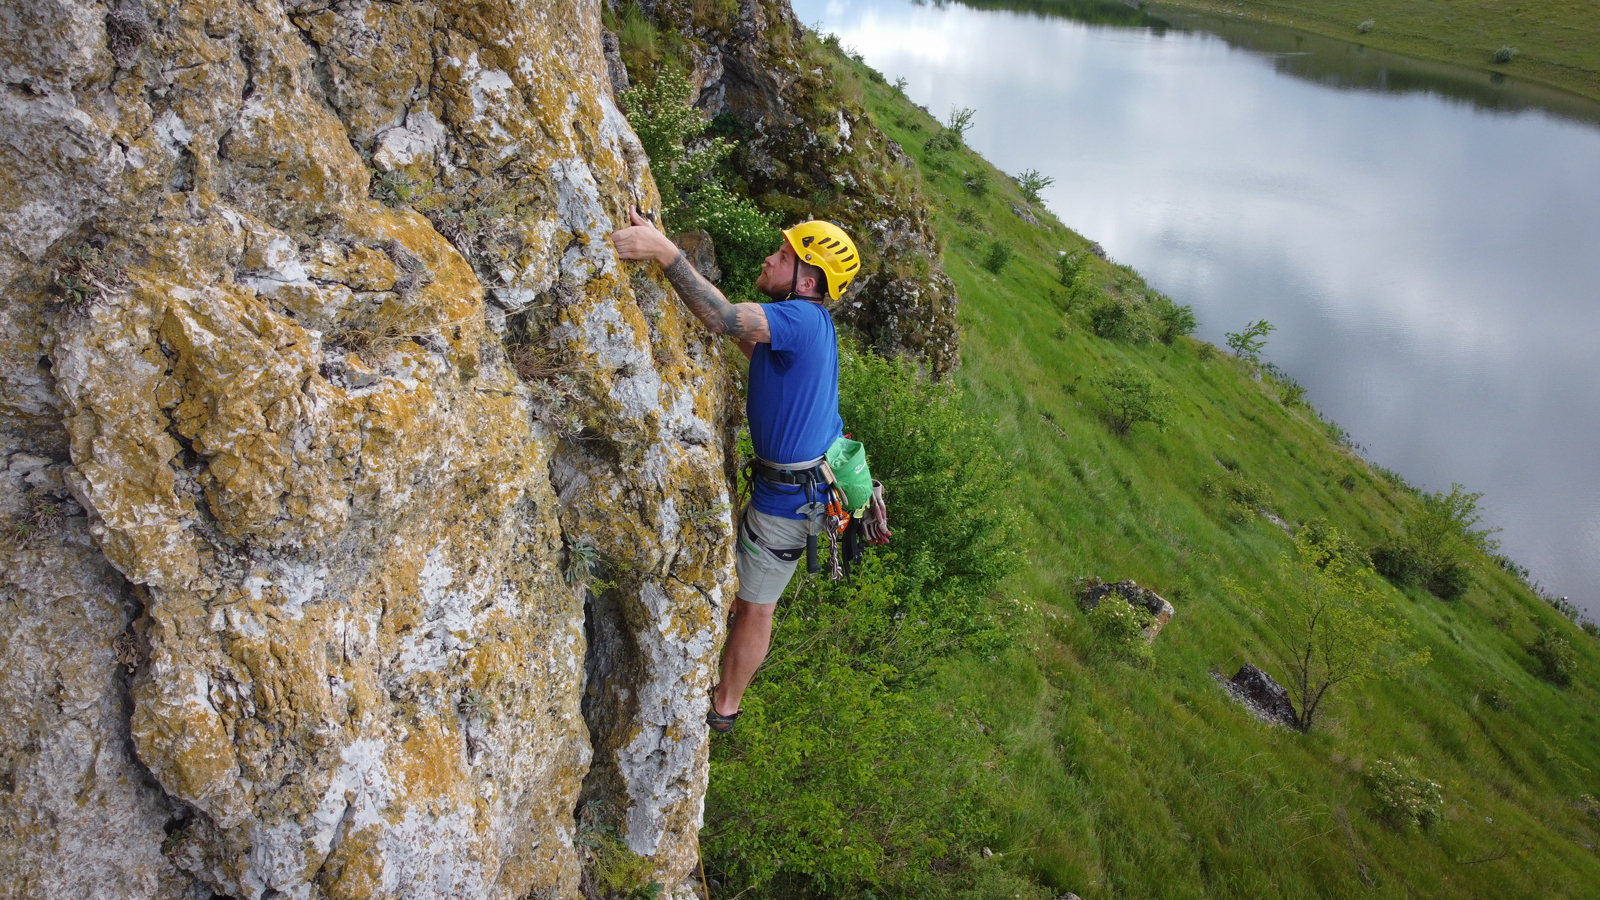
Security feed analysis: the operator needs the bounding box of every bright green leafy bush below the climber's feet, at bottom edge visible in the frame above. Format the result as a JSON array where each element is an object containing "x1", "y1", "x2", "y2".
[{"x1": 701, "y1": 656, "x2": 994, "y2": 898}]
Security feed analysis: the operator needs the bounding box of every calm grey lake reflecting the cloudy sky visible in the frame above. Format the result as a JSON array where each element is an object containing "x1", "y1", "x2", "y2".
[{"x1": 794, "y1": 0, "x2": 1600, "y2": 618}]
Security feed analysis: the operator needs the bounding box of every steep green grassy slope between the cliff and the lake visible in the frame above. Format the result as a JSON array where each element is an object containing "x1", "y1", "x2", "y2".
[{"x1": 851, "y1": 50, "x2": 1600, "y2": 900}]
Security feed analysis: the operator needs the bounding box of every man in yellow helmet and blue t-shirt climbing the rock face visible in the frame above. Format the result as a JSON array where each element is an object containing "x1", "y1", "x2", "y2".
[{"x1": 611, "y1": 210, "x2": 861, "y2": 733}]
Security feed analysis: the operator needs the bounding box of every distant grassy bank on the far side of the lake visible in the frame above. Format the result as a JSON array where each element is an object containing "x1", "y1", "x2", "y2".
[{"x1": 1160, "y1": 0, "x2": 1600, "y2": 99}]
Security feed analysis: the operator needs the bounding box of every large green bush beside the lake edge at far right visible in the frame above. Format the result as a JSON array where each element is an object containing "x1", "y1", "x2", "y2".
[{"x1": 1373, "y1": 484, "x2": 1499, "y2": 601}]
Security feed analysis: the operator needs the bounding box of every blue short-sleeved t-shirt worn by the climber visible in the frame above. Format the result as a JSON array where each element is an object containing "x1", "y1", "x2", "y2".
[{"x1": 744, "y1": 299, "x2": 845, "y2": 519}]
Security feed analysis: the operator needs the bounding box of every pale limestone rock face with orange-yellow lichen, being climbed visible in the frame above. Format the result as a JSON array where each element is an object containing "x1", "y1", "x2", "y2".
[{"x1": 0, "y1": 0, "x2": 736, "y2": 900}]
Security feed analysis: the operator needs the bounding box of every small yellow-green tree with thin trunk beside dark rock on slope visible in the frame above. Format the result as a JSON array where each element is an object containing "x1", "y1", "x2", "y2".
[{"x1": 1234, "y1": 522, "x2": 1429, "y2": 732}]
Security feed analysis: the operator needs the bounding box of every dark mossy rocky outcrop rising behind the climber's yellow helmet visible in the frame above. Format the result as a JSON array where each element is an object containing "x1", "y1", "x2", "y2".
[{"x1": 643, "y1": 0, "x2": 960, "y2": 375}]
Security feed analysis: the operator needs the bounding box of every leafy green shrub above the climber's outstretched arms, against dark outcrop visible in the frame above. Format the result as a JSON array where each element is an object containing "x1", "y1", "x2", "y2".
[{"x1": 621, "y1": 66, "x2": 779, "y2": 299}]
